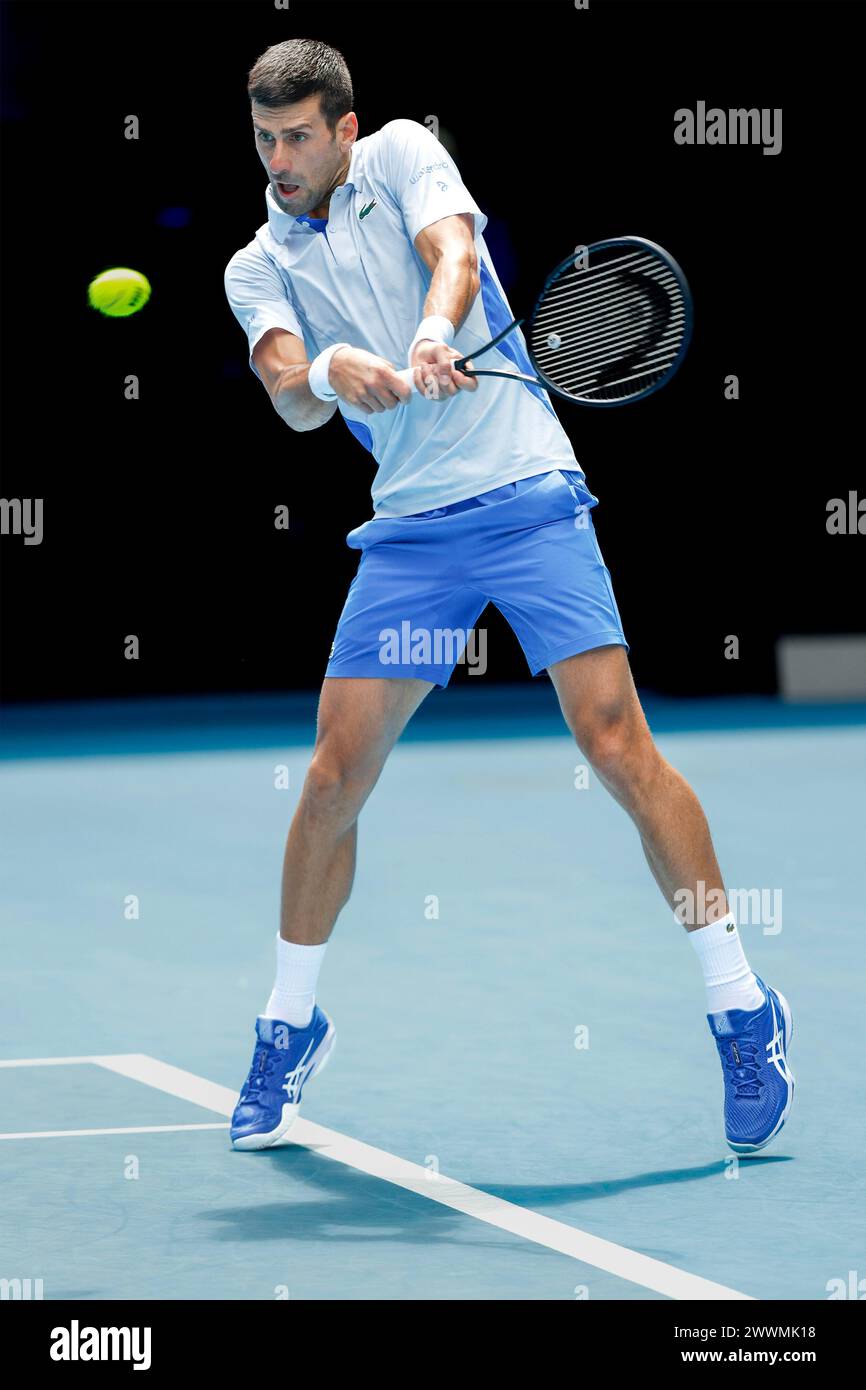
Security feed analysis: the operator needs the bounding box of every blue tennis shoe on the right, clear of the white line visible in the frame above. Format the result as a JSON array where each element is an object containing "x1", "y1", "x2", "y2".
[{"x1": 706, "y1": 976, "x2": 794, "y2": 1158}]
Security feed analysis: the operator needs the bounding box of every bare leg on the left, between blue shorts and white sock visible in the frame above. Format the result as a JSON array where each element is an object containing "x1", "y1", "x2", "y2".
[{"x1": 279, "y1": 677, "x2": 434, "y2": 945}]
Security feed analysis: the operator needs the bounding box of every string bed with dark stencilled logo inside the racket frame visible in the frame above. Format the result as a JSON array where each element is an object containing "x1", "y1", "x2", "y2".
[{"x1": 531, "y1": 247, "x2": 688, "y2": 400}]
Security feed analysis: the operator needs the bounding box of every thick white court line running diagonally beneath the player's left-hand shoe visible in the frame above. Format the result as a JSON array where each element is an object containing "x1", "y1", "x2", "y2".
[{"x1": 6, "y1": 1052, "x2": 752, "y2": 1301}]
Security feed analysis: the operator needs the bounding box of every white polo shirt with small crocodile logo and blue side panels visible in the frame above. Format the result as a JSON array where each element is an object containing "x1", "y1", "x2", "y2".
[{"x1": 225, "y1": 120, "x2": 582, "y2": 517}]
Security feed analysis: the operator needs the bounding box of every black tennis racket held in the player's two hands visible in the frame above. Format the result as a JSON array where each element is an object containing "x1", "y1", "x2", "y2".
[{"x1": 398, "y1": 236, "x2": 692, "y2": 406}]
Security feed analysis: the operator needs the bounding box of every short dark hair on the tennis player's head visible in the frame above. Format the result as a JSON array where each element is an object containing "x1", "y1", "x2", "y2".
[{"x1": 246, "y1": 39, "x2": 354, "y2": 135}]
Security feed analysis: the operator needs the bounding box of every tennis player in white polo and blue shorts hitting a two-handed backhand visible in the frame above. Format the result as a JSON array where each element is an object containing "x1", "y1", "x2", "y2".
[{"x1": 225, "y1": 39, "x2": 794, "y2": 1155}]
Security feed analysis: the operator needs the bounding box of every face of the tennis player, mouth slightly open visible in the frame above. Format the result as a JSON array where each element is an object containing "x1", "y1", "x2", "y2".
[{"x1": 252, "y1": 95, "x2": 357, "y2": 217}]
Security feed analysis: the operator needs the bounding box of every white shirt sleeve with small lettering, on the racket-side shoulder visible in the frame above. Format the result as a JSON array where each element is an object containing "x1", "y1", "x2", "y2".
[{"x1": 381, "y1": 120, "x2": 487, "y2": 242}]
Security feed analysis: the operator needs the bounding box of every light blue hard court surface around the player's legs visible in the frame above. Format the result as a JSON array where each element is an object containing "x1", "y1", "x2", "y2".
[{"x1": 0, "y1": 692, "x2": 866, "y2": 1301}]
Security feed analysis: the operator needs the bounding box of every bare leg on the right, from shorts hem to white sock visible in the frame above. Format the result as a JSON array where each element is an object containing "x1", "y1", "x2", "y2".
[{"x1": 549, "y1": 646, "x2": 728, "y2": 931}]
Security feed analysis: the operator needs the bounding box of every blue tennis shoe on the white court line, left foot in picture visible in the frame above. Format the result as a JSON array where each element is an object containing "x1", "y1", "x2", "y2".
[{"x1": 231, "y1": 1005, "x2": 336, "y2": 1148}]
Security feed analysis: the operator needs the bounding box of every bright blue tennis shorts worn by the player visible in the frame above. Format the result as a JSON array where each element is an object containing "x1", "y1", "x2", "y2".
[{"x1": 325, "y1": 468, "x2": 628, "y2": 685}]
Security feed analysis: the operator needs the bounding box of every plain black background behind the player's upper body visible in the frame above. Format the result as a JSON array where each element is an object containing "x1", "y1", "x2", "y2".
[{"x1": 0, "y1": 0, "x2": 866, "y2": 702}]
